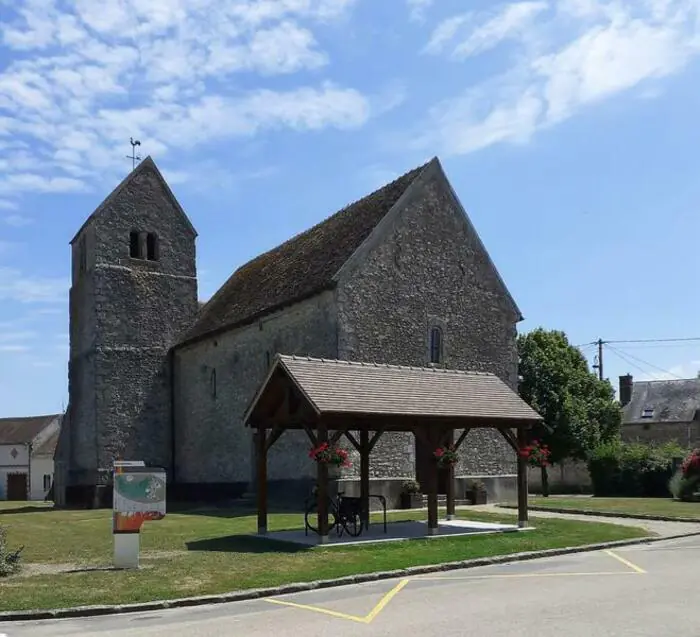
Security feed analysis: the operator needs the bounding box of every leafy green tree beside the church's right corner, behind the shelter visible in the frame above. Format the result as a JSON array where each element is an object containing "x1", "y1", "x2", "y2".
[{"x1": 518, "y1": 328, "x2": 621, "y2": 496}]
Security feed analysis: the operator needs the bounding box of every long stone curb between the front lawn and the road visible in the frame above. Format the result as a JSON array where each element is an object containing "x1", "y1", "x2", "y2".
[{"x1": 0, "y1": 531, "x2": 700, "y2": 622}]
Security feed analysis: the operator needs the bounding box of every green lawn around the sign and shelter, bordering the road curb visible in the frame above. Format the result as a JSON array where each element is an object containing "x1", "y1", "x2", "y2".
[{"x1": 0, "y1": 504, "x2": 647, "y2": 610}]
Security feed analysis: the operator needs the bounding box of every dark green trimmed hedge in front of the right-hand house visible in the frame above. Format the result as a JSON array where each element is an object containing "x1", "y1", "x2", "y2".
[{"x1": 588, "y1": 441, "x2": 688, "y2": 498}]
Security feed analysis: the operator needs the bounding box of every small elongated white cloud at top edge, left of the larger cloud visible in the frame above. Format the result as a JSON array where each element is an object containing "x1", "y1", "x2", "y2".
[{"x1": 426, "y1": 1, "x2": 549, "y2": 59}]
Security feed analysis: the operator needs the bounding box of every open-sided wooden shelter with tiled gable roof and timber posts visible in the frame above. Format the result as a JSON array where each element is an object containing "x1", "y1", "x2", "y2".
[{"x1": 244, "y1": 355, "x2": 542, "y2": 543}]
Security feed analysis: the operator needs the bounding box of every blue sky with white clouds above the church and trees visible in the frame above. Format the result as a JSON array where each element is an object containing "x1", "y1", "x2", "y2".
[{"x1": 0, "y1": 0, "x2": 700, "y2": 416}]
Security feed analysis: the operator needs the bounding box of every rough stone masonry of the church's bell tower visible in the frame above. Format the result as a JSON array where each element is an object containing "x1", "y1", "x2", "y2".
[{"x1": 69, "y1": 167, "x2": 198, "y2": 484}]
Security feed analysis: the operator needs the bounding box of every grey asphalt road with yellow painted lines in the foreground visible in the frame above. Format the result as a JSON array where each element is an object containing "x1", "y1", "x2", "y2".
[{"x1": 0, "y1": 537, "x2": 700, "y2": 637}]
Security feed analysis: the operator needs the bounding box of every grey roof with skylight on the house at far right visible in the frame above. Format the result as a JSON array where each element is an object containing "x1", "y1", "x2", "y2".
[{"x1": 622, "y1": 378, "x2": 700, "y2": 424}]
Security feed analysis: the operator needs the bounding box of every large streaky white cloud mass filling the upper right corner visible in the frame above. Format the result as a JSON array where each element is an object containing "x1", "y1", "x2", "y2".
[{"x1": 418, "y1": 0, "x2": 700, "y2": 155}]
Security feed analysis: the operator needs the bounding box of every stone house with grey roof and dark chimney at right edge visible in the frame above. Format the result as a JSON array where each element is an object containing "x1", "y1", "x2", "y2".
[{"x1": 619, "y1": 374, "x2": 700, "y2": 448}]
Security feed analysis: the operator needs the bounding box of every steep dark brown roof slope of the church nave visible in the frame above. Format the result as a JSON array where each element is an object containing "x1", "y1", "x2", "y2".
[{"x1": 183, "y1": 164, "x2": 428, "y2": 343}]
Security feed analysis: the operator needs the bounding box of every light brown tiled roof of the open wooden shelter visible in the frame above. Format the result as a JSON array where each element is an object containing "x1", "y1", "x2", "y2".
[{"x1": 246, "y1": 355, "x2": 542, "y2": 424}]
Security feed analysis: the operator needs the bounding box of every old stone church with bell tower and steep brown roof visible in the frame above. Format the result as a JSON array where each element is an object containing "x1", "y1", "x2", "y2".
[{"x1": 56, "y1": 158, "x2": 522, "y2": 504}]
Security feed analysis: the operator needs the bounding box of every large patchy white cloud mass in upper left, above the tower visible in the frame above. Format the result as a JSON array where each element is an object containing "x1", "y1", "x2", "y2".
[{"x1": 0, "y1": 0, "x2": 370, "y2": 202}]
